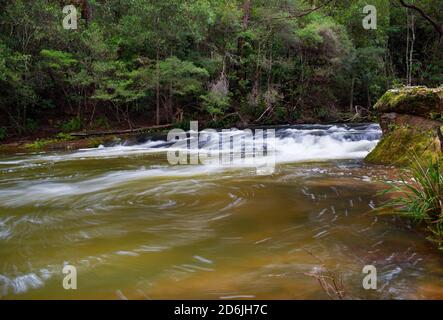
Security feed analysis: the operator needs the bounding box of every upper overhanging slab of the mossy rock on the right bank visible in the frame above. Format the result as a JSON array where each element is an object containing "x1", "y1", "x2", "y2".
[{"x1": 374, "y1": 86, "x2": 443, "y2": 120}]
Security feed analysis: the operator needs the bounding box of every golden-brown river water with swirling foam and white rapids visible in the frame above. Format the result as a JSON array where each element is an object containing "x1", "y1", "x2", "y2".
[{"x1": 0, "y1": 124, "x2": 443, "y2": 299}]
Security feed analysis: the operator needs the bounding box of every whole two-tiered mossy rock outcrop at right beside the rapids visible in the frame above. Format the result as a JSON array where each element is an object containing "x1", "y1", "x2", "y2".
[{"x1": 366, "y1": 86, "x2": 443, "y2": 166}]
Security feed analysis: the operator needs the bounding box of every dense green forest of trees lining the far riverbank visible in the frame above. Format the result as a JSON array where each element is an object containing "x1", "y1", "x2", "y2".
[{"x1": 0, "y1": 0, "x2": 443, "y2": 139}]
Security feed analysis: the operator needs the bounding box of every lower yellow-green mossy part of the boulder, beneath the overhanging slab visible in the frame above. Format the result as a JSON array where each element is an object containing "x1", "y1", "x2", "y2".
[{"x1": 365, "y1": 126, "x2": 441, "y2": 166}]
